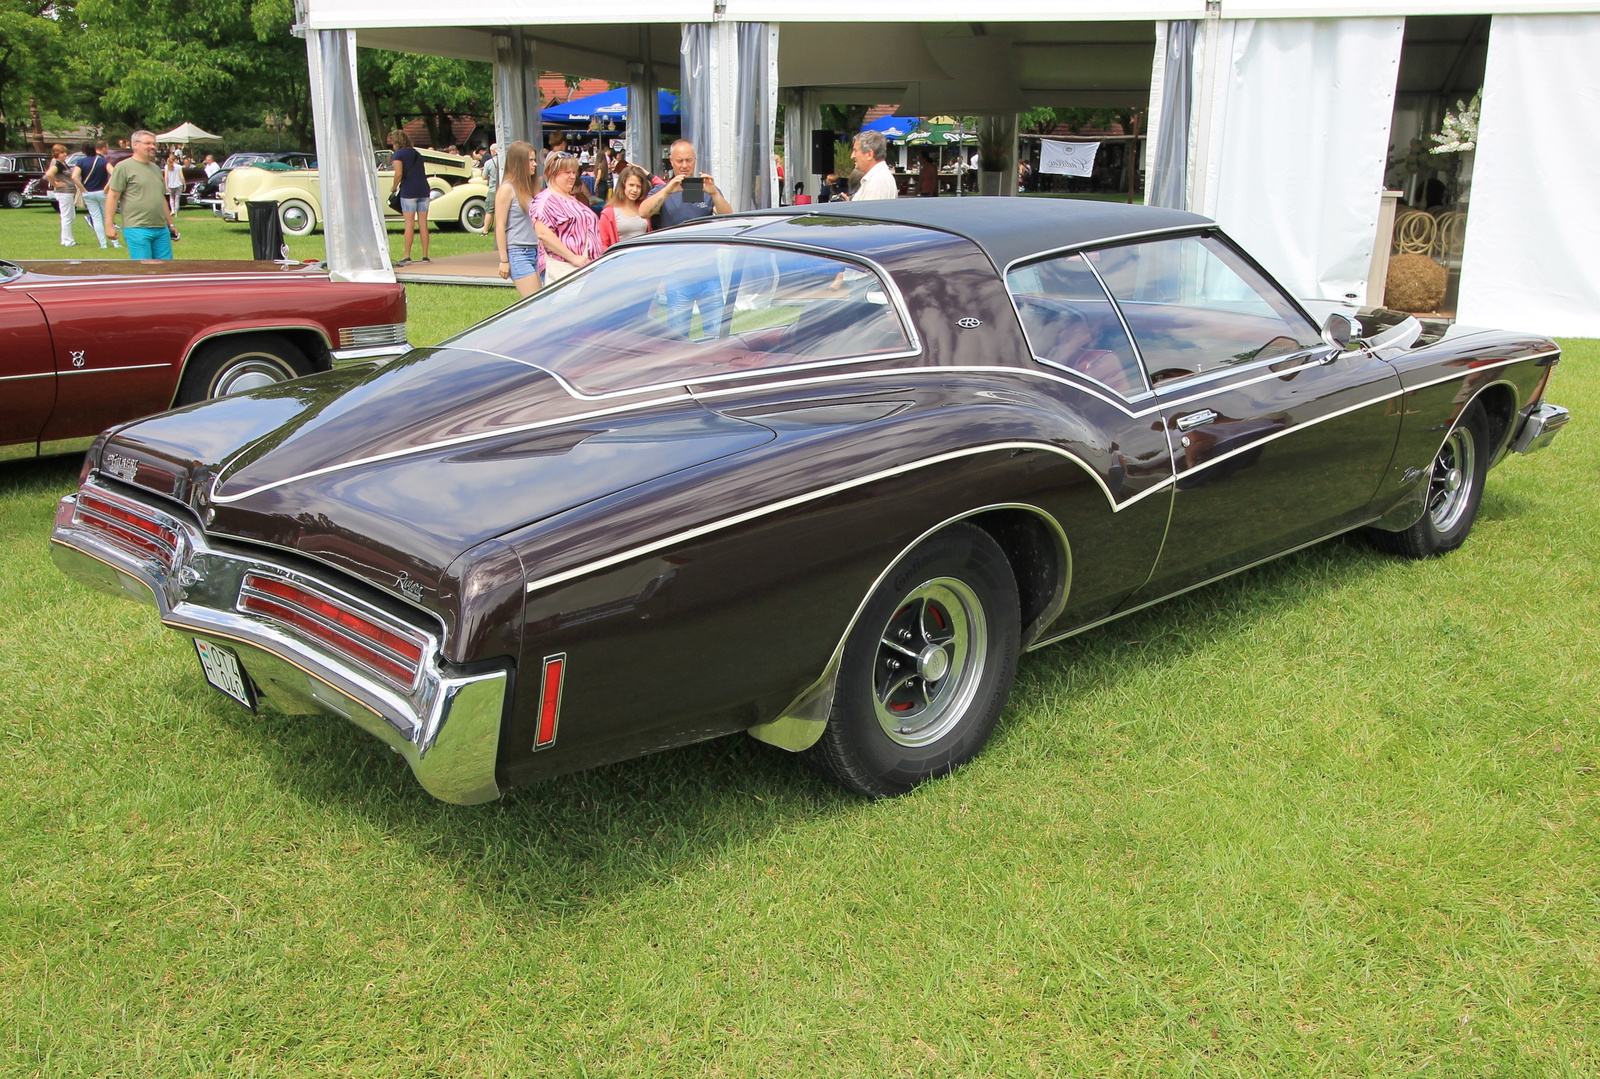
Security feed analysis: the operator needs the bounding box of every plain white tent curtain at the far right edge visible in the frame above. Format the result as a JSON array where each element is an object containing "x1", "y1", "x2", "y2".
[{"x1": 1456, "y1": 14, "x2": 1600, "y2": 338}]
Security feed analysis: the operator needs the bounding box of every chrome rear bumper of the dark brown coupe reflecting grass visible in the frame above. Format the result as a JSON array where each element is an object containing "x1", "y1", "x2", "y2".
[{"x1": 50, "y1": 477, "x2": 509, "y2": 805}]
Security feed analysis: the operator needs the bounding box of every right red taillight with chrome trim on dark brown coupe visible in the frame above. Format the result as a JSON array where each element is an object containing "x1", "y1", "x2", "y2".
[{"x1": 238, "y1": 573, "x2": 427, "y2": 690}]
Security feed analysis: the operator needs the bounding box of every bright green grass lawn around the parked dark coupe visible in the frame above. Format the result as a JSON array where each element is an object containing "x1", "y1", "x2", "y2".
[{"x1": 0, "y1": 199, "x2": 1600, "y2": 1079}]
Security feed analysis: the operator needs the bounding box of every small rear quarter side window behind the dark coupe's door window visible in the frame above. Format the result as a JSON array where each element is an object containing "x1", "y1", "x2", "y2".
[{"x1": 1006, "y1": 255, "x2": 1146, "y2": 397}]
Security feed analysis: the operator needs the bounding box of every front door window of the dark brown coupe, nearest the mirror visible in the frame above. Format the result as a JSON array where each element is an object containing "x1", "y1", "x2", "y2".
[{"x1": 1088, "y1": 237, "x2": 1320, "y2": 386}]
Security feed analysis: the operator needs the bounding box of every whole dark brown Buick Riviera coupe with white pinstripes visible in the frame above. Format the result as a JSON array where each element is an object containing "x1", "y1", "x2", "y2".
[{"x1": 53, "y1": 199, "x2": 1566, "y2": 804}]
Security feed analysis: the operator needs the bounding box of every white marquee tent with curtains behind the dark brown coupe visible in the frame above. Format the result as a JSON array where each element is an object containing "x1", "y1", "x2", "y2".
[{"x1": 299, "y1": 0, "x2": 1600, "y2": 336}]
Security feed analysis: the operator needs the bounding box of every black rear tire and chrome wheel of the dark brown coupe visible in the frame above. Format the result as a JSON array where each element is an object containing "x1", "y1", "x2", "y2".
[{"x1": 803, "y1": 523, "x2": 1021, "y2": 797}]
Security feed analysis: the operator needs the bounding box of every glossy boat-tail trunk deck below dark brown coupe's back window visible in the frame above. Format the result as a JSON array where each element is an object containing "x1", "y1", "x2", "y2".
[{"x1": 99, "y1": 347, "x2": 774, "y2": 599}]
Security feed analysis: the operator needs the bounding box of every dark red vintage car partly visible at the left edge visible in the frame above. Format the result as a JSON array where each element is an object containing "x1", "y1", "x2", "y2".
[{"x1": 0, "y1": 259, "x2": 406, "y2": 461}]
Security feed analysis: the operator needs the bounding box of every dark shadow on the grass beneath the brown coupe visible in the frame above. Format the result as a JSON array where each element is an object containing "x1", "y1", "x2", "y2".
[{"x1": 196, "y1": 528, "x2": 1414, "y2": 917}]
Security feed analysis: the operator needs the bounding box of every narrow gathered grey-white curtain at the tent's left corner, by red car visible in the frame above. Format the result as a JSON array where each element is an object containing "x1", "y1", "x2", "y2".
[{"x1": 306, "y1": 30, "x2": 395, "y2": 282}]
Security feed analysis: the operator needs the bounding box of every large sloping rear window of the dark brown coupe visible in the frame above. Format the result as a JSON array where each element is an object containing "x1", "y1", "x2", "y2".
[{"x1": 450, "y1": 243, "x2": 912, "y2": 394}]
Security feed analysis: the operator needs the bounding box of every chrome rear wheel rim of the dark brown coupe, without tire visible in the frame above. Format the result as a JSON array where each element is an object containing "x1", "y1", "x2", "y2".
[{"x1": 872, "y1": 576, "x2": 989, "y2": 746}]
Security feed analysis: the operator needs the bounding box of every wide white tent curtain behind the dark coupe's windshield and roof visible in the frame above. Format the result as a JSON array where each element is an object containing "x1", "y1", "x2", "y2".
[{"x1": 1189, "y1": 18, "x2": 1405, "y2": 304}]
